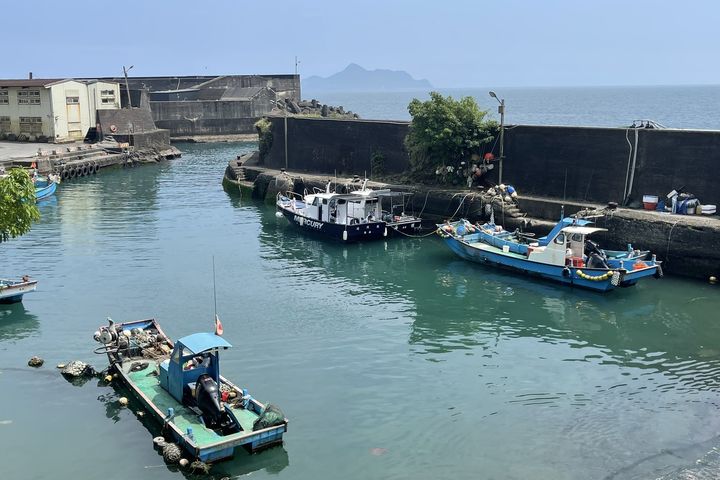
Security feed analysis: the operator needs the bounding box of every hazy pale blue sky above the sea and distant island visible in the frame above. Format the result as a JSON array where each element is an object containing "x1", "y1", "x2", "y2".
[{"x1": 0, "y1": 0, "x2": 720, "y2": 87}]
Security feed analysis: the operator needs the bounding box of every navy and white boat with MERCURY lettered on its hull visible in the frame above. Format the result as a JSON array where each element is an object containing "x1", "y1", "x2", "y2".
[{"x1": 276, "y1": 180, "x2": 422, "y2": 242}]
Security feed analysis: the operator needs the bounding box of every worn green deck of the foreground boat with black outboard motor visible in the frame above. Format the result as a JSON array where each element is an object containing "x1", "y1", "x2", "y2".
[{"x1": 125, "y1": 362, "x2": 258, "y2": 448}]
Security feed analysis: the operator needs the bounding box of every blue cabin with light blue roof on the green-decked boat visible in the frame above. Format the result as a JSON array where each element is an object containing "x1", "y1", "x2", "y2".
[{"x1": 160, "y1": 333, "x2": 232, "y2": 403}]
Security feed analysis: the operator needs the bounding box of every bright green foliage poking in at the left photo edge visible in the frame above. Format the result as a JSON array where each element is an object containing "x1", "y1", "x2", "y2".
[{"x1": 0, "y1": 168, "x2": 40, "y2": 242}]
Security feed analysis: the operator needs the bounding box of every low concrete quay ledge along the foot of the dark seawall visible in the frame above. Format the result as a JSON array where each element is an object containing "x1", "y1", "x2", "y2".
[{"x1": 223, "y1": 153, "x2": 720, "y2": 279}]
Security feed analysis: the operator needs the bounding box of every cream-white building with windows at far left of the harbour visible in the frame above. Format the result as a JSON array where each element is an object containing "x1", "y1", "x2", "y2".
[{"x1": 0, "y1": 79, "x2": 120, "y2": 143}]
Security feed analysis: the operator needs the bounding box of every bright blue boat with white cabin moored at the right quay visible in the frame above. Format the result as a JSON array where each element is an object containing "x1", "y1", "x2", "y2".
[{"x1": 437, "y1": 218, "x2": 662, "y2": 292}]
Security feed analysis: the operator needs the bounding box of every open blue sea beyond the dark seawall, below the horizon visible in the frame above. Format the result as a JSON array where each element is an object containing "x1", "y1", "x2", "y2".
[{"x1": 312, "y1": 85, "x2": 720, "y2": 130}]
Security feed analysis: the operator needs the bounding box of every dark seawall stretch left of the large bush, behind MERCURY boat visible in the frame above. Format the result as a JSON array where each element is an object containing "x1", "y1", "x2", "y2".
[{"x1": 264, "y1": 117, "x2": 409, "y2": 177}]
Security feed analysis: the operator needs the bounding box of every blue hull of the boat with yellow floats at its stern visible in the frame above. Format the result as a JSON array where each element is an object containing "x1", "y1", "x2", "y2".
[{"x1": 443, "y1": 236, "x2": 657, "y2": 292}]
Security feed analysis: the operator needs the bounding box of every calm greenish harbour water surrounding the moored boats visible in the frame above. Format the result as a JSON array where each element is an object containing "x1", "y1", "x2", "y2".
[{"x1": 0, "y1": 144, "x2": 720, "y2": 480}]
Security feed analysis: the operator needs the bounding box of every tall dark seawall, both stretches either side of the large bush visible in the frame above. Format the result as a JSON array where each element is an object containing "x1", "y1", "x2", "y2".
[{"x1": 265, "y1": 118, "x2": 720, "y2": 204}]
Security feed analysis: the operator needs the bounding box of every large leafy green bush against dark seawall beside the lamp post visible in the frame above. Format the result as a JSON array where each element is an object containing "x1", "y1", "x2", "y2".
[{"x1": 405, "y1": 92, "x2": 498, "y2": 180}]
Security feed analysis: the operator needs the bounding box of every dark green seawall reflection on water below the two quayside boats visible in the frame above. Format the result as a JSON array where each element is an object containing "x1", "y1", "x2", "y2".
[{"x1": 246, "y1": 200, "x2": 720, "y2": 402}]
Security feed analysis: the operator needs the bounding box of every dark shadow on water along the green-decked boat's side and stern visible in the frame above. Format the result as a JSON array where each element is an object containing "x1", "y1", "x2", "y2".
[{"x1": 96, "y1": 372, "x2": 290, "y2": 480}]
